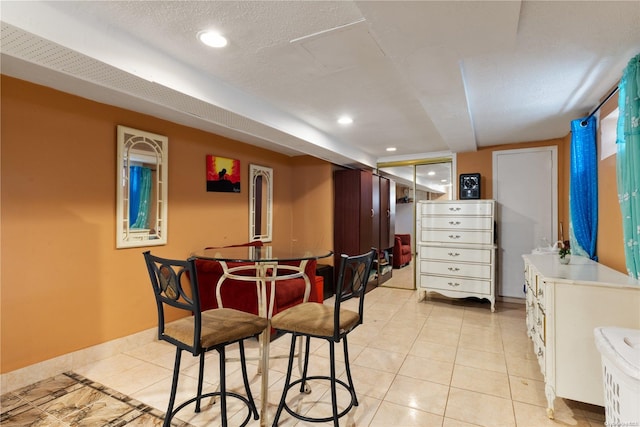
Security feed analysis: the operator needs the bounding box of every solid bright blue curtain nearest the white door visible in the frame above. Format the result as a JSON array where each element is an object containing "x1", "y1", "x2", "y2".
[{"x1": 569, "y1": 116, "x2": 598, "y2": 260}]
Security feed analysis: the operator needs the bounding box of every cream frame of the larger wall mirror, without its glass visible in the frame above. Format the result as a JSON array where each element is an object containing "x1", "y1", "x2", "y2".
[{"x1": 116, "y1": 125, "x2": 169, "y2": 249}]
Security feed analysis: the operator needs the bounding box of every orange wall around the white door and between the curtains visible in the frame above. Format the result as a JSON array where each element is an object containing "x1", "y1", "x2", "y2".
[{"x1": 457, "y1": 132, "x2": 627, "y2": 274}]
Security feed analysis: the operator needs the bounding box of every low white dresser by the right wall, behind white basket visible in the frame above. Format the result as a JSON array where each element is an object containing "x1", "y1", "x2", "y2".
[{"x1": 523, "y1": 255, "x2": 640, "y2": 418}]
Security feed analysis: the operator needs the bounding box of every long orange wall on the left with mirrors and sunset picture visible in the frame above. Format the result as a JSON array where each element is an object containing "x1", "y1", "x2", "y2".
[{"x1": 0, "y1": 76, "x2": 333, "y2": 373}]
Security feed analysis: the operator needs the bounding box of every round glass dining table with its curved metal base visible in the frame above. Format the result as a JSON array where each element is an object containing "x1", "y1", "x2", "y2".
[{"x1": 192, "y1": 245, "x2": 333, "y2": 426}]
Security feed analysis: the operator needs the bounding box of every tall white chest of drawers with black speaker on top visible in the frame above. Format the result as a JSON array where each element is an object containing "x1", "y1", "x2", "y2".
[{"x1": 416, "y1": 200, "x2": 496, "y2": 311}]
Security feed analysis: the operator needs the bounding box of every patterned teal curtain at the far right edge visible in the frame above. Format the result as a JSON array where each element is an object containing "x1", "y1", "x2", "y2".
[{"x1": 616, "y1": 54, "x2": 640, "y2": 279}]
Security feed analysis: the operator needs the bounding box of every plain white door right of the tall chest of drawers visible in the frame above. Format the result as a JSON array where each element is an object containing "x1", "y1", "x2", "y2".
[{"x1": 493, "y1": 146, "x2": 558, "y2": 298}]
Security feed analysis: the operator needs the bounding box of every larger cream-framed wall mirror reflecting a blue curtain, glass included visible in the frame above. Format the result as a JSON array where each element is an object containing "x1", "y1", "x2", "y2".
[{"x1": 116, "y1": 126, "x2": 169, "y2": 248}]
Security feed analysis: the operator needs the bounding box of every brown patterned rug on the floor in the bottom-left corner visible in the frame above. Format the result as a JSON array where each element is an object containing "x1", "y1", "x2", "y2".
[{"x1": 0, "y1": 372, "x2": 189, "y2": 427}]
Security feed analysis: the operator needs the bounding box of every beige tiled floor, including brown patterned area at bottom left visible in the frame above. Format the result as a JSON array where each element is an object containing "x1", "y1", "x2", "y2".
[{"x1": 1, "y1": 286, "x2": 604, "y2": 427}]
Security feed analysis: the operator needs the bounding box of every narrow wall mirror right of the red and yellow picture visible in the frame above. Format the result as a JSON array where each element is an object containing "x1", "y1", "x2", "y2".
[{"x1": 249, "y1": 165, "x2": 273, "y2": 242}]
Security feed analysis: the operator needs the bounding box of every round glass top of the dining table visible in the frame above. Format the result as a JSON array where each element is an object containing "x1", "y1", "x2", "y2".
[{"x1": 192, "y1": 245, "x2": 333, "y2": 262}]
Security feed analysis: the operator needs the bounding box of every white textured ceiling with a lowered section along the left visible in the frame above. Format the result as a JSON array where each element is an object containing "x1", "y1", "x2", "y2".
[{"x1": 0, "y1": 1, "x2": 640, "y2": 171}]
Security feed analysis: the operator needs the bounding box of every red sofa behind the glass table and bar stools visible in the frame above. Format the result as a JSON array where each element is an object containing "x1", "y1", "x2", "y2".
[{"x1": 191, "y1": 245, "x2": 323, "y2": 322}]
